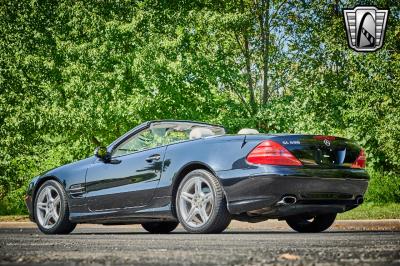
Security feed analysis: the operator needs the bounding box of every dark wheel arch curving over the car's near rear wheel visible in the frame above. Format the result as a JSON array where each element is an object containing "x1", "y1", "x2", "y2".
[{"x1": 171, "y1": 161, "x2": 226, "y2": 217}]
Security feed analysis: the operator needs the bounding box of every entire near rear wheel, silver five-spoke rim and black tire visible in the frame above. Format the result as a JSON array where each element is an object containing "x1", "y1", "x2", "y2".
[{"x1": 175, "y1": 170, "x2": 231, "y2": 233}]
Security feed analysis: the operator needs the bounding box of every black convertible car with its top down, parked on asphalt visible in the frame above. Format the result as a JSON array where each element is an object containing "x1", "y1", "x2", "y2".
[{"x1": 26, "y1": 120, "x2": 369, "y2": 234}]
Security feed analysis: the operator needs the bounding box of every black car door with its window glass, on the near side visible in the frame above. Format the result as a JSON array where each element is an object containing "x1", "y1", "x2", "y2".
[{"x1": 86, "y1": 129, "x2": 166, "y2": 211}]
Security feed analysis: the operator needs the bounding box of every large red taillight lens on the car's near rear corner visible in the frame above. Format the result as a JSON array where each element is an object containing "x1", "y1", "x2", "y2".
[{"x1": 246, "y1": 140, "x2": 302, "y2": 166}]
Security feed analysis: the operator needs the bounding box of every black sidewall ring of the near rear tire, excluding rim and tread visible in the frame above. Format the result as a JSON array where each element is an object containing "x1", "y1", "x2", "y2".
[{"x1": 175, "y1": 170, "x2": 223, "y2": 232}]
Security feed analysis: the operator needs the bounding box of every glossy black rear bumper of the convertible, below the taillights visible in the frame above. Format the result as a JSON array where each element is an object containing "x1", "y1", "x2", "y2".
[{"x1": 217, "y1": 170, "x2": 368, "y2": 218}]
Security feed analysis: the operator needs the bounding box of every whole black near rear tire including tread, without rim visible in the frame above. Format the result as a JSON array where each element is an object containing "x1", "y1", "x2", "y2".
[{"x1": 175, "y1": 169, "x2": 231, "y2": 234}]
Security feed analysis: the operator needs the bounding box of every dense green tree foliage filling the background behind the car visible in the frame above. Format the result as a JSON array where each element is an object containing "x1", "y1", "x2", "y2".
[{"x1": 0, "y1": 0, "x2": 400, "y2": 213}]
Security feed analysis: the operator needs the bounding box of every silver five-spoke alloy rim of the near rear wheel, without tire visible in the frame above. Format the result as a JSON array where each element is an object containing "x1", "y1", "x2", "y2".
[{"x1": 179, "y1": 176, "x2": 214, "y2": 227}]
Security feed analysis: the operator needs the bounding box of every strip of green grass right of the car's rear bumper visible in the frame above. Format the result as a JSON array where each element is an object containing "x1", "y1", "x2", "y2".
[{"x1": 338, "y1": 202, "x2": 400, "y2": 220}]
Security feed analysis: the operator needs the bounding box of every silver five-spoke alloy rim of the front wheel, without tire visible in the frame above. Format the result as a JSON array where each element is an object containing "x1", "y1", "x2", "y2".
[{"x1": 36, "y1": 186, "x2": 61, "y2": 229}]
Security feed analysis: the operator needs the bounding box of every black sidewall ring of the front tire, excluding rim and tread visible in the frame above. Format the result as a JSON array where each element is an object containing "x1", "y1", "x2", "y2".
[{"x1": 33, "y1": 180, "x2": 66, "y2": 234}]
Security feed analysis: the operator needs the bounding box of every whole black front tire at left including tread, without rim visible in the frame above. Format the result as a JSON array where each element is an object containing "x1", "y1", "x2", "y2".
[{"x1": 33, "y1": 180, "x2": 76, "y2": 234}]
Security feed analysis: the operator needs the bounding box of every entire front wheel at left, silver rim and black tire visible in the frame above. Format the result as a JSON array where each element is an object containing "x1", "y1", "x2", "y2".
[{"x1": 34, "y1": 180, "x2": 76, "y2": 234}]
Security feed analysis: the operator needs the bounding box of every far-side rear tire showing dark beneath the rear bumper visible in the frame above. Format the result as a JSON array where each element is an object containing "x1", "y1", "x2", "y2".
[{"x1": 286, "y1": 213, "x2": 336, "y2": 233}]
